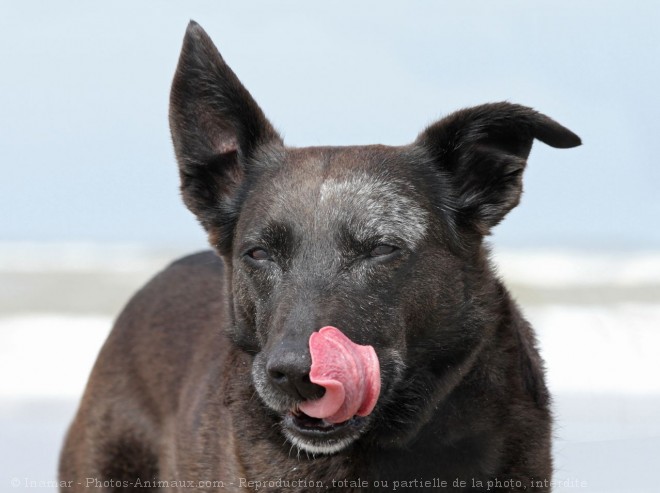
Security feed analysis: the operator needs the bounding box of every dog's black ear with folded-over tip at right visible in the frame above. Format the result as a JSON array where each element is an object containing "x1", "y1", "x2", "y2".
[{"x1": 416, "y1": 102, "x2": 581, "y2": 235}]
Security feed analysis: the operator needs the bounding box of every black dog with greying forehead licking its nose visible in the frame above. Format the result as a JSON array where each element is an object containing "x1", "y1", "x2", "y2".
[{"x1": 60, "y1": 21, "x2": 581, "y2": 491}]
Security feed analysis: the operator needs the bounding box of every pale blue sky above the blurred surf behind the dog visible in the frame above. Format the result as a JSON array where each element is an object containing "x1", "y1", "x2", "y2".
[{"x1": 0, "y1": 0, "x2": 660, "y2": 248}]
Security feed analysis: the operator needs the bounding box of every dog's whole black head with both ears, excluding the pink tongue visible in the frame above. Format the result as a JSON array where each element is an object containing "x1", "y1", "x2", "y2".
[{"x1": 170, "y1": 23, "x2": 580, "y2": 453}]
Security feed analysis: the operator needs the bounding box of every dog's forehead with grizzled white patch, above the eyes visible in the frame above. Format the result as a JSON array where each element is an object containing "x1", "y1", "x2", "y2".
[{"x1": 250, "y1": 146, "x2": 428, "y2": 244}]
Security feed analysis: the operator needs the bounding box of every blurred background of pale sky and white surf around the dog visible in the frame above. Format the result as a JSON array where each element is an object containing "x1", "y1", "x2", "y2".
[{"x1": 0, "y1": 0, "x2": 660, "y2": 492}]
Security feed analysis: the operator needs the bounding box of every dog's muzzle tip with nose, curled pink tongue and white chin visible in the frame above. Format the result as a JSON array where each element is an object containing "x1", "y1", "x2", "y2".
[{"x1": 253, "y1": 326, "x2": 381, "y2": 454}]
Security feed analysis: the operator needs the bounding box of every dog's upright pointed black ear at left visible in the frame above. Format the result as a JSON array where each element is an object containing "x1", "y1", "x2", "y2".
[{"x1": 170, "y1": 21, "x2": 282, "y2": 253}]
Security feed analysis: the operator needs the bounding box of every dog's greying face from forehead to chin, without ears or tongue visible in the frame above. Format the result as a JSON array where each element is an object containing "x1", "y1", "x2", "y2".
[{"x1": 231, "y1": 147, "x2": 446, "y2": 453}]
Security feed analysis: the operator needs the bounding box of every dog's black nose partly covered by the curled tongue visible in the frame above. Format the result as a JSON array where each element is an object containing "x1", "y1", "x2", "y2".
[{"x1": 266, "y1": 350, "x2": 325, "y2": 401}]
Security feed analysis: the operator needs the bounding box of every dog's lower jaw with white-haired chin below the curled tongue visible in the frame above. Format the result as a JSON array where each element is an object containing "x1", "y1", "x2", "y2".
[{"x1": 282, "y1": 408, "x2": 369, "y2": 455}]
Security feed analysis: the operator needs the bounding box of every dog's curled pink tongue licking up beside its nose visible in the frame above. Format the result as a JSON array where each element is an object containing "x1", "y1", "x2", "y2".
[{"x1": 300, "y1": 326, "x2": 380, "y2": 423}]
